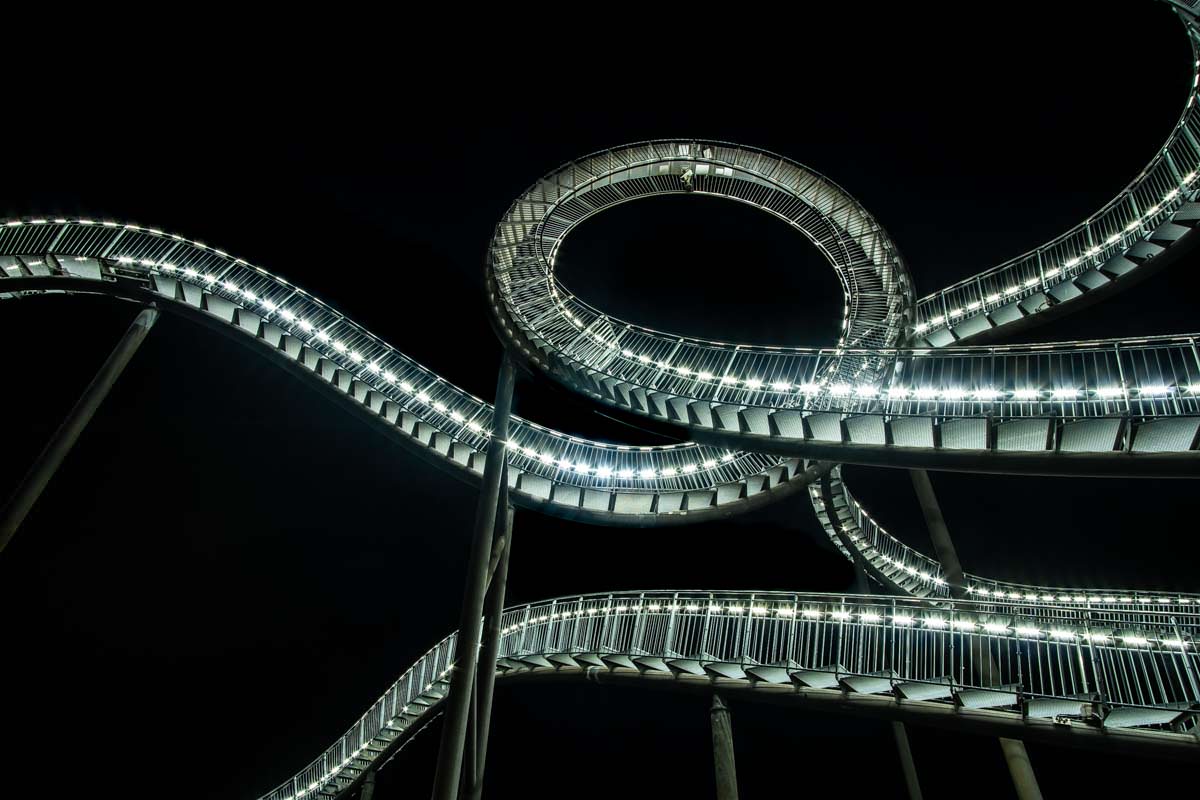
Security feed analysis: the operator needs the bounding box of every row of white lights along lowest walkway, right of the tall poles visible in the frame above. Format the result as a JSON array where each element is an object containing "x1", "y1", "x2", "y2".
[{"x1": 502, "y1": 603, "x2": 1189, "y2": 648}]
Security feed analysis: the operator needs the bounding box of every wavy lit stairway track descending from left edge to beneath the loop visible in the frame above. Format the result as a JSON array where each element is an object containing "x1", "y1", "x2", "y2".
[{"x1": 0, "y1": 266, "x2": 817, "y2": 525}]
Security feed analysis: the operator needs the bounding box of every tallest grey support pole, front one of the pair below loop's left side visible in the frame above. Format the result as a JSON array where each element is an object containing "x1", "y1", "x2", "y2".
[{"x1": 433, "y1": 353, "x2": 515, "y2": 800}]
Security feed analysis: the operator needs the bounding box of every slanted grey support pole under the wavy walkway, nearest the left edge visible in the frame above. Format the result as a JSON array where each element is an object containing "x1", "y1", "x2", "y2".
[{"x1": 0, "y1": 306, "x2": 158, "y2": 553}]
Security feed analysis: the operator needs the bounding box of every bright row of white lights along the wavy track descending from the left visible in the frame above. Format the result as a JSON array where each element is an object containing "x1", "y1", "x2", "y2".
[{"x1": 100, "y1": 251, "x2": 737, "y2": 489}]
